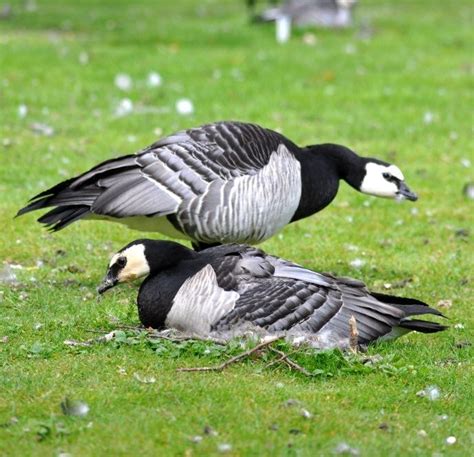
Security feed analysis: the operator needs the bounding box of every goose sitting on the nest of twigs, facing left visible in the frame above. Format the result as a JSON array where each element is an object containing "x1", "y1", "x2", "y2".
[{"x1": 98, "y1": 239, "x2": 445, "y2": 347}]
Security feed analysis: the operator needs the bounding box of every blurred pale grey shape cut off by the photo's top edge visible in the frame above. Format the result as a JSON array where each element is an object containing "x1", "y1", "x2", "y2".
[{"x1": 252, "y1": 0, "x2": 357, "y2": 28}]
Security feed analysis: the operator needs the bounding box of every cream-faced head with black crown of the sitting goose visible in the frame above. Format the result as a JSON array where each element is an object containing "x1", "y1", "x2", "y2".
[{"x1": 97, "y1": 239, "x2": 195, "y2": 294}]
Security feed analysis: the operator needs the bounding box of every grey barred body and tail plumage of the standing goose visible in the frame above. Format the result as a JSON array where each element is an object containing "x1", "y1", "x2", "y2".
[{"x1": 18, "y1": 122, "x2": 301, "y2": 243}]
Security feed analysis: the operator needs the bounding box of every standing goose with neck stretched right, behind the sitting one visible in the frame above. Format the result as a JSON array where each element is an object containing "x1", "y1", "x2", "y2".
[{"x1": 18, "y1": 122, "x2": 417, "y2": 249}]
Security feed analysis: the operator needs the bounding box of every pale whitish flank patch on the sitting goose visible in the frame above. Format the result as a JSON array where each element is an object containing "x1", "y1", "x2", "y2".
[{"x1": 165, "y1": 265, "x2": 240, "y2": 335}]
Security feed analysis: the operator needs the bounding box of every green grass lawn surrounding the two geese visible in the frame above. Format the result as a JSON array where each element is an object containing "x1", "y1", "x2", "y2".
[{"x1": 0, "y1": 0, "x2": 474, "y2": 456}]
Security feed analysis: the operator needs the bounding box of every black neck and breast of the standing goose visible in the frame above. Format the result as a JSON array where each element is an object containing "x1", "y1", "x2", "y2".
[{"x1": 292, "y1": 144, "x2": 365, "y2": 221}]
